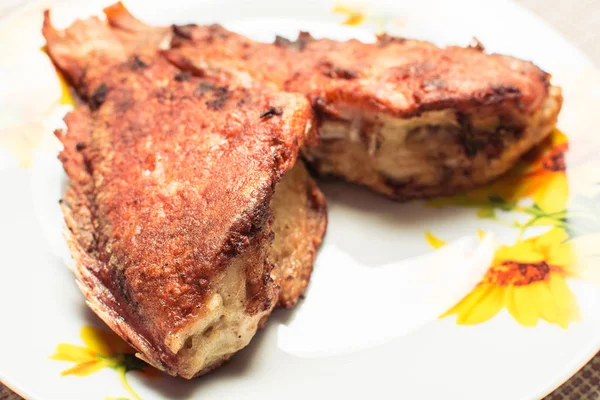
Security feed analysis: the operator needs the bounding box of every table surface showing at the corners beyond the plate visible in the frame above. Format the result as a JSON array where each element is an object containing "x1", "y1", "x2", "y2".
[{"x1": 0, "y1": 0, "x2": 600, "y2": 400}]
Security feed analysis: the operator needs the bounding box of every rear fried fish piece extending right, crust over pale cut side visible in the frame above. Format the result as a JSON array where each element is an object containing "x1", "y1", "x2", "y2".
[{"x1": 173, "y1": 25, "x2": 562, "y2": 200}]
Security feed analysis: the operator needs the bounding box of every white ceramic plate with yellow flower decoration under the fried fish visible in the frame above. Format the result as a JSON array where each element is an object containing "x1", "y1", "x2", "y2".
[{"x1": 0, "y1": 0, "x2": 600, "y2": 400}]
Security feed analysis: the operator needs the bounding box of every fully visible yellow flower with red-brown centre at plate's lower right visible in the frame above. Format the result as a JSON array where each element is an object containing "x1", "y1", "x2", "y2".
[{"x1": 427, "y1": 228, "x2": 580, "y2": 328}]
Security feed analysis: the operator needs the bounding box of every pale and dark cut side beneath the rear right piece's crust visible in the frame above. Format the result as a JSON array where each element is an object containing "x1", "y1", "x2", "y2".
[{"x1": 304, "y1": 87, "x2": 562, "y2": 200}]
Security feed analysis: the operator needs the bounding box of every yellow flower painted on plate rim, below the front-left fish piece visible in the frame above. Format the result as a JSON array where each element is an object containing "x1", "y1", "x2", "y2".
[{"x1": 50, "y1": 326, "x2": 156, "y2": 400}]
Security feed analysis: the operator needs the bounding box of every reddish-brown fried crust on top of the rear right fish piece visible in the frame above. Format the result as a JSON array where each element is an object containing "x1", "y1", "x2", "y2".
[{"x1": 173, "y1": 25, "x2": 550, "y2": 118}]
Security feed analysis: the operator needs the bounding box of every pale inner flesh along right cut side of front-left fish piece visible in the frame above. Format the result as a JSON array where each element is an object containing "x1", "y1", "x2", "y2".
[{"x1": 173, "y1": 160, "x2": 327, "y2": 377}]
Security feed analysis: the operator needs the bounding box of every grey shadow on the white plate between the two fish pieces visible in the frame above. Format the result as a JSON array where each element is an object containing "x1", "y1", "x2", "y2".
[{"x1": 317, "y1": 180, "x2": 474, "y2": 267}]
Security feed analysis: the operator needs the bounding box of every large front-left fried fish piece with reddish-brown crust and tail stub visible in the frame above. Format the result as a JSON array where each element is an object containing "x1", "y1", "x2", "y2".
[{"x1": 43, "y1": 5, "x2": 324, "y2": 378}]
